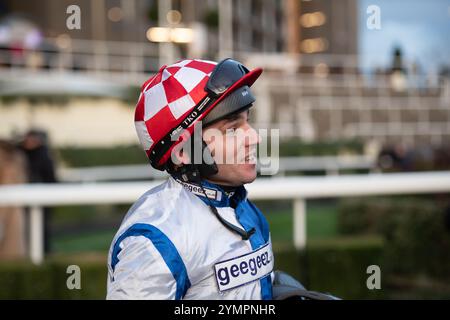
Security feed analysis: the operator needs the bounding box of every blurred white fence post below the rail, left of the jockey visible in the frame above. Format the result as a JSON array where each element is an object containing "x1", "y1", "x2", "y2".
[{"x1": 30, "y1": 206, "x2": 44, "y2": 264}]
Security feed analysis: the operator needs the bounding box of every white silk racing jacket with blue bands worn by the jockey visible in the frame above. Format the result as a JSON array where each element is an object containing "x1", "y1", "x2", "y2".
[{"x1": 107, "y1": 177, "x2": 274, "y2": 300}]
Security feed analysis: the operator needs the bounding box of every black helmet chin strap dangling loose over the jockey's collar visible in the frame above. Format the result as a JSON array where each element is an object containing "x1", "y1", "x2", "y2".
[{"x1": 175, "y1": 139, "x2": 256, "y2": 240}]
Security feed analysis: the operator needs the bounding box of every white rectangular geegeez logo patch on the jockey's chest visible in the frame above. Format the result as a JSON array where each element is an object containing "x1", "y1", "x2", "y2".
[{"x1": 214, "y1": 243, "x2": 273, "y2": 292}]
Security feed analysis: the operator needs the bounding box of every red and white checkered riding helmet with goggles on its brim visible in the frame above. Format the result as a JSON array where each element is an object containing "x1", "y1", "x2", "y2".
[{"x1": 134, "y1": 59, "x2": 262, "y2": 170}]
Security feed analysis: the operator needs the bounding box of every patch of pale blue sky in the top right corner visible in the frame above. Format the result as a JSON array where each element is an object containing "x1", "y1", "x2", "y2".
[{"x1": 359, "y1": 0, "x2": 450, "y2": 73}]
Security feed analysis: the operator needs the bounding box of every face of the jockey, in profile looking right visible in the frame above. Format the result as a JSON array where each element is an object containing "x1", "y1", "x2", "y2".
[{"x1": 203, "y1": 110, "x2": 260, "y2": 186}]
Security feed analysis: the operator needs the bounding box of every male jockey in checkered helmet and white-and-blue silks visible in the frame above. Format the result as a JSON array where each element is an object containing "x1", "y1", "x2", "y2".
[{"x1": 107, "y1": 59, "x2": 274, "y2": 300}]
